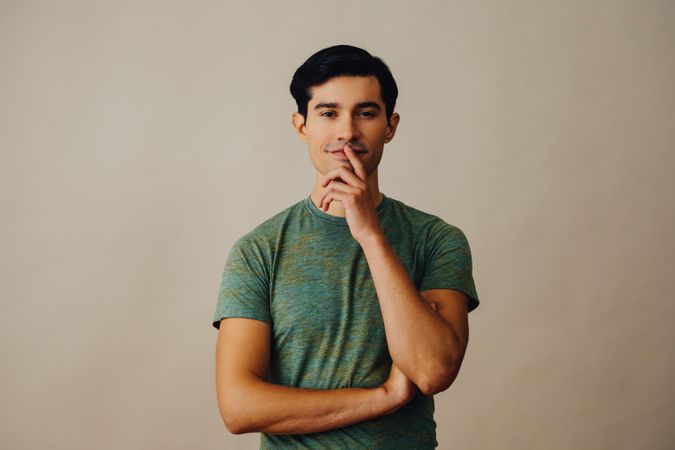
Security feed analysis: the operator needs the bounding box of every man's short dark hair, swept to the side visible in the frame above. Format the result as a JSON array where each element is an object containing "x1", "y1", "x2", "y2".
[{"x1": 291, "y1": 45, "x2": 398, "y2": 123}]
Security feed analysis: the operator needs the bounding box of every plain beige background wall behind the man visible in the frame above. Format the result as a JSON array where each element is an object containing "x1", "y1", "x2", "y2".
[{"x1": 0, "y1": 0, "x2": 675, "y2": 450}]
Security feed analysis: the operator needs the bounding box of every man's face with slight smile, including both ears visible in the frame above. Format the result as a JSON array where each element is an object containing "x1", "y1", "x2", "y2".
[{"x1": 293, "y1": 76, "x2": 399, "y2": 175}]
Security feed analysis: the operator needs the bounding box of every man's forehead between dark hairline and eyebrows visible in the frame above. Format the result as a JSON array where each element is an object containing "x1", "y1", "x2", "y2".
[{"x1": 308, "y1": 75, "x2": 384, "y2": 108}]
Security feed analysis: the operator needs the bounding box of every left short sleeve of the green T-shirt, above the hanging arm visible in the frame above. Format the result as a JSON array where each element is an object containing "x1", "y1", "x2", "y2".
[{"x1": 213, "y1": 237, "x2": 272, "y2": 329}]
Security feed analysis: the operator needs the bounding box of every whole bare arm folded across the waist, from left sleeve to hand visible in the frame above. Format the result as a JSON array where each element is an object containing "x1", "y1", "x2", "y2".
[{"x1": 216, "y1": 318, "x2": 415, "y2": 434}]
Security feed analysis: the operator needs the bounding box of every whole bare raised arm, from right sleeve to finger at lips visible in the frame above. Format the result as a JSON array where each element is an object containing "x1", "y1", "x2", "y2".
[{"x1": 319, "y1": 144, "x2": 468, "y2": 395}]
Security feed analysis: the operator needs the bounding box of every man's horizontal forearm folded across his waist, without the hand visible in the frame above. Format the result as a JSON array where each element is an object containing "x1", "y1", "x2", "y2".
[{"x1": 227, "y1": 380, "x2": 400, "y2": 434}]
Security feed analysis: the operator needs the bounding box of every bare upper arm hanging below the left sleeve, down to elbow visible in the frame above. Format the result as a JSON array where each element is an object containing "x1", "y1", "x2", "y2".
[{"x1": 216, "y1": 317, "x2": 271, "y2": 428}]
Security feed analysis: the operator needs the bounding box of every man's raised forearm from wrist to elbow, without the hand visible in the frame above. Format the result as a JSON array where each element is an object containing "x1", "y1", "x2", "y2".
[{"x1": 361, "y1": 235, "x2": 461, "y2": 391}]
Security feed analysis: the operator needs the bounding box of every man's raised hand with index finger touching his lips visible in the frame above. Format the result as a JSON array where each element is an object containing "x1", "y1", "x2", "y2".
[{"x1": 319, "y1": 143, "x2": 384, "y2": 242}]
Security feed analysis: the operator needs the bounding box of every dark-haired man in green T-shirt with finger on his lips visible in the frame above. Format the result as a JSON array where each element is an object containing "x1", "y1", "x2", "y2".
[{"x1": 213, "y1": 45, "x2": 479, "y2": 449}]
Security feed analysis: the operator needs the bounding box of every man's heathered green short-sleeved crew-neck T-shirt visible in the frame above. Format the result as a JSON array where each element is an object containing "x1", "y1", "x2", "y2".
[{"x1": 213, "y1": 195, "x2": 479, "y2": 449}]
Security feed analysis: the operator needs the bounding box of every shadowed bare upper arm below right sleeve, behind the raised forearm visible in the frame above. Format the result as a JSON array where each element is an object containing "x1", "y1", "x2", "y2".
[{"x1": 420, "y1": 289, "x2": 469, "y2": 361}]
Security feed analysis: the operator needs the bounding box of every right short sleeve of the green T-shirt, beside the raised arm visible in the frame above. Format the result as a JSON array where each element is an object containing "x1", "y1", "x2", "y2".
[{"x1": 419, "y1": 219, "x2": 480, "y2": 312}]
